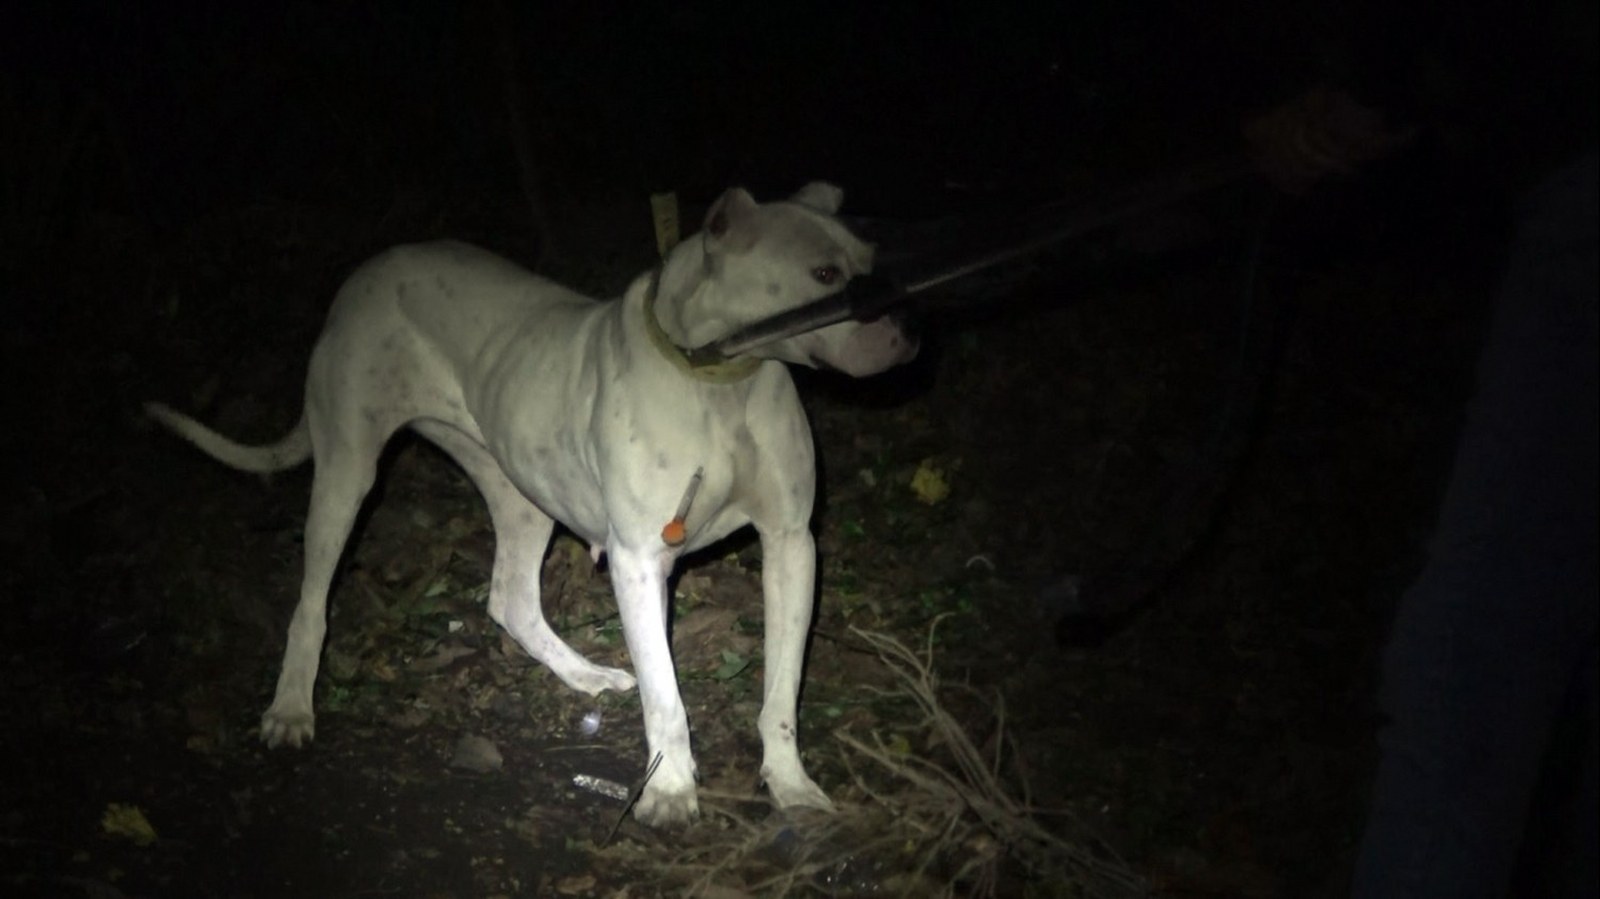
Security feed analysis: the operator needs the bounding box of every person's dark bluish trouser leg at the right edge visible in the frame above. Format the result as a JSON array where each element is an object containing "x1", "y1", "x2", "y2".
[{"x1": 1354, "y1": 155, "x2": 1600, "y2": 899}]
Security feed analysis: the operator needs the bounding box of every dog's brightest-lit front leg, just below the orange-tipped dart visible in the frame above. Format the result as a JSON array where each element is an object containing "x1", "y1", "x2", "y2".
[{"x1": 606, "y1": 541, "x2": 699, "y2": 827}]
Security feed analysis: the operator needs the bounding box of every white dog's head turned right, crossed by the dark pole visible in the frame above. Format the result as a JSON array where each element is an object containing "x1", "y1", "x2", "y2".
[{"x1": 685, "y1": 181, "x2": 917, "y2": 378}]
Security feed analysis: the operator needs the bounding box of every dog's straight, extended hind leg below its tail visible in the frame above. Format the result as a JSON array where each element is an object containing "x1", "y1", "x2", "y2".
[{"x1": 261, "y1": 421, "x2": 387, "y2": 747}]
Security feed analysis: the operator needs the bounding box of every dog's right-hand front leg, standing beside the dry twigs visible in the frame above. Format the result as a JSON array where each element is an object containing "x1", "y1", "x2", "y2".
[{"x1": 758, "y1": 528, "x2": 834, "y2": 811}]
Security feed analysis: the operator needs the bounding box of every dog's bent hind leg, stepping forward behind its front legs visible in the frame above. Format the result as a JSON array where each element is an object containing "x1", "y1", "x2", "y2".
[{"x1": 413, "y1": 421, "x2": 634, "y2": 696}]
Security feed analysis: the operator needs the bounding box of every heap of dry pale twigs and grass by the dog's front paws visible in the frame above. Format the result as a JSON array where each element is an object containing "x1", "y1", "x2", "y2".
[{"x1": 603, "y1": 621, "x2": 1149, "y2": 899}]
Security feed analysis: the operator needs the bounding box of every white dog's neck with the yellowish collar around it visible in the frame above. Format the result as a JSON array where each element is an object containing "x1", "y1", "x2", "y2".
[{"x1": 643, "y1": 238, "x2": 762, "y2": 384}]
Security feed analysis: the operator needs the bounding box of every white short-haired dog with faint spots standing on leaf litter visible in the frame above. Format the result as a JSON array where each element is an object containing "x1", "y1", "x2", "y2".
[{"x1": 147, "y1": 184, "x2": 917, "y2": 825}]
